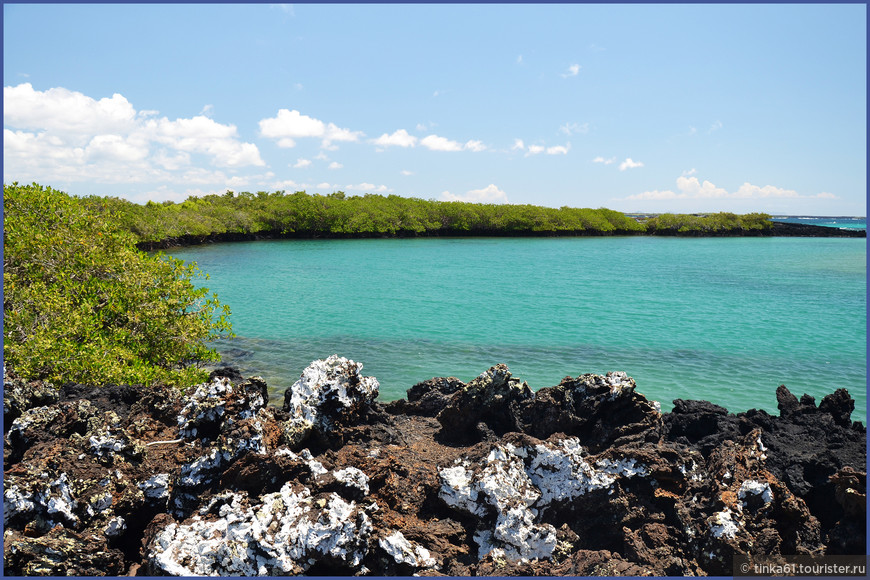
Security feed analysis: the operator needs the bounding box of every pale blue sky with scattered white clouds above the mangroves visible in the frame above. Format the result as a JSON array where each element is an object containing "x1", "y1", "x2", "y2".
[{"x1": 3, "y1": 4, "x2": 867, "y2": 215}]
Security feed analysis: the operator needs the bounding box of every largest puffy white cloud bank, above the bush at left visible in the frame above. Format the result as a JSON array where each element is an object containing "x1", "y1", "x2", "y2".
[{"x1": 3, "y1": 83, "x2": 265, "y2": 183}]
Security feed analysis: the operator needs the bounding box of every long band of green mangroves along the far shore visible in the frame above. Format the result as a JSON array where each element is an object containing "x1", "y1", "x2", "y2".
[{"x1": 87, "y1": 191, "x2": 645, "y2": 241}]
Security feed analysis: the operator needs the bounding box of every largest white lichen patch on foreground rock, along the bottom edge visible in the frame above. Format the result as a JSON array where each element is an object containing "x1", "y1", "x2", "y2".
[{"x1": 148, "y1": 483, "x2": 372, "y2": 576}]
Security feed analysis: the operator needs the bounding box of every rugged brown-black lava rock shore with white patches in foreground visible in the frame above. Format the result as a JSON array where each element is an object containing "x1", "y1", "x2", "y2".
[{"x1": 3, "y1": 356, "x2": 866, "y2": 576}]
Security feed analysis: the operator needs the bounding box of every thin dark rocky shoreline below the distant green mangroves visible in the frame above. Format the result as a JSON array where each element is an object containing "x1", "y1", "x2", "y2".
[{"x1": 136, "y1": 221, "x2": 867, "y2": 251}]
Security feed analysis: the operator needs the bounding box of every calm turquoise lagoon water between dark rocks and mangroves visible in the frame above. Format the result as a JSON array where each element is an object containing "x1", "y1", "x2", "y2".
[{"x1": 172, "y1": 237, "x2": 867, "y2": 421}]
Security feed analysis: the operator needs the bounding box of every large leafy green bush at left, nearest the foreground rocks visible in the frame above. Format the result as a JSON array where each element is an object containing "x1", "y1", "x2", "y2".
[{"x1": 3, "y1": 183, "x2": 230, "y2": 387}]
